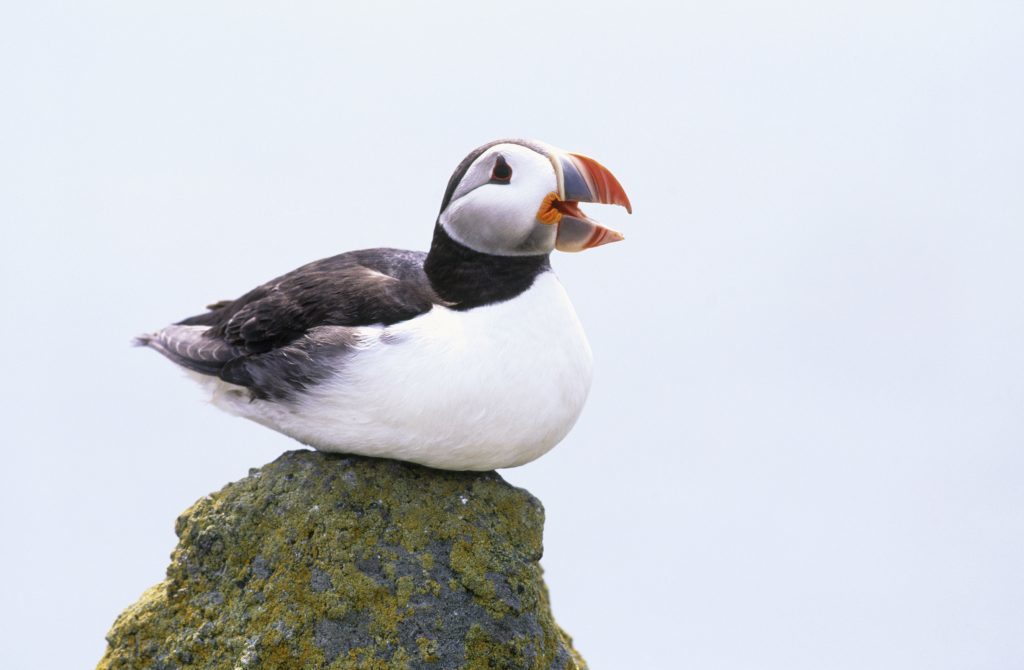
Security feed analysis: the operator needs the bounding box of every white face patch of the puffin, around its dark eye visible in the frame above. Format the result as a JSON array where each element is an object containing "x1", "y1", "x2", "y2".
[{"x1": 440, "y1": 143, "x2": 558, "y2": 256}]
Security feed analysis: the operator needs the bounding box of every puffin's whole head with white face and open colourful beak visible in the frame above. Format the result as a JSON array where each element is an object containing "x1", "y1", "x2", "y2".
[{"x1": 437, "y1": 139, "x2": 633, "y2": 256}]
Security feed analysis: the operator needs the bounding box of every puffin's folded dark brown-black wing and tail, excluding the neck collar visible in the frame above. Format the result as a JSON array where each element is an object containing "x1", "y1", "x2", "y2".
[{"x1": 138, "y1": 249, "x2": 442, "y2": 397}]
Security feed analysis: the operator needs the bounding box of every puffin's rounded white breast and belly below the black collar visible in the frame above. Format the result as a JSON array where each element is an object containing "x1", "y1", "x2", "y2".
[{"x1": 215, "y1": 273, "x2": 592, "y2": 470}]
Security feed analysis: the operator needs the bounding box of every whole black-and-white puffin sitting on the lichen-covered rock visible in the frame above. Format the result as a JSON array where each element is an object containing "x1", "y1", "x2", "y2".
[{"x1": 135, "y1": 138, "x2": 632, "y2": 470}]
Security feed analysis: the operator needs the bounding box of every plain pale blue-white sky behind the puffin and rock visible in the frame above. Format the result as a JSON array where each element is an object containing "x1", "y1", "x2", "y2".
[{"x1": 0, "y1": 0, "x2": 1024, "y2": 670}]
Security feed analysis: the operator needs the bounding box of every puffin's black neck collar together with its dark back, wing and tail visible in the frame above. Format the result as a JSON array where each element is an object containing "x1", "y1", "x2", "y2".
[{"x1": 138, "y1": 232, "x2": 550, "y2": 400}]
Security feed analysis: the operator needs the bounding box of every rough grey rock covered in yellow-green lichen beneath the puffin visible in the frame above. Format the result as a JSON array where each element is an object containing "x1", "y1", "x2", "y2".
[{"x1": 98, "y1": 451, "x2": 586, "y2": 670}]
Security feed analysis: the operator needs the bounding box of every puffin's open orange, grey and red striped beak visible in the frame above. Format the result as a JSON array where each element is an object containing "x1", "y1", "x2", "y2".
[{"x1": 538, "y1": 152, "x2": 633, "y2": 251}]
